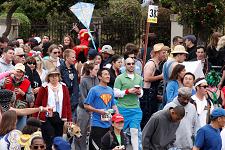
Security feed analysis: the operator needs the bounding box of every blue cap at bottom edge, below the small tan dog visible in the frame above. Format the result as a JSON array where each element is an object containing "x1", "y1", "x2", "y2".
[{"x1": 53, "y1": 136, "x2": 71, "y2": 150}]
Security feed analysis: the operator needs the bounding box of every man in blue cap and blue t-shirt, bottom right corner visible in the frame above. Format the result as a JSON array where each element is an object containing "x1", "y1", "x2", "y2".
[{"x1": 193, "y1": 108, "x2": 225, "y2": 150}]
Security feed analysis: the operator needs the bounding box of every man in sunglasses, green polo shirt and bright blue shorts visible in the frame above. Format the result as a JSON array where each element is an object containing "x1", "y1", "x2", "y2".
[{"x1": 114, "y1": 58, "x2": 143, "y2": 150}]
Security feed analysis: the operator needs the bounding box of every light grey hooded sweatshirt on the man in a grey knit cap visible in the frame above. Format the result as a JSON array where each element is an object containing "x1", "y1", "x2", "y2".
[{"x1": 164, "y1": 97, "x2": 200, "y2": 149}]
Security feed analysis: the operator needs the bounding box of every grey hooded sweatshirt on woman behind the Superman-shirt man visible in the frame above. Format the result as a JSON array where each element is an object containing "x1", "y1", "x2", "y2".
[{"x1": 79, "y1": 76, "x2": 99, "y2": 108}]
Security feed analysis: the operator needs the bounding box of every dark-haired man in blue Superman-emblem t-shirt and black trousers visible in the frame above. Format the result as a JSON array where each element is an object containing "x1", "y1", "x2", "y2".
[{"x1": 84, "y1": 68, "x2": 118, "y2": 150}]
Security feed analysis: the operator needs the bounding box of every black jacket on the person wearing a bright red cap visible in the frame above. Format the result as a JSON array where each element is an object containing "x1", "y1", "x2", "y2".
[{"x1": 101, "y1": 131, "x2": 126, "y2": 150}]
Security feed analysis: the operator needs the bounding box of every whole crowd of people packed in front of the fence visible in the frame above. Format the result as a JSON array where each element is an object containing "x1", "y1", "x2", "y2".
[{"x1": 0, "y1": 28, "x2": 225, "y2": 150}]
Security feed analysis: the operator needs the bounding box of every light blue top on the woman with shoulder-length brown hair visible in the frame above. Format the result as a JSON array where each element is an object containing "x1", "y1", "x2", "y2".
[{"x1": 166, "y1": 80, "x2": 179, "y2": 103}]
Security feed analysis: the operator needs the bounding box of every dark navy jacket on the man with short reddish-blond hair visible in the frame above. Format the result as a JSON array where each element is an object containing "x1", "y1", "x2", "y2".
[{"x1": 59, "y1": 60, "x2": 79, "y2": 108}]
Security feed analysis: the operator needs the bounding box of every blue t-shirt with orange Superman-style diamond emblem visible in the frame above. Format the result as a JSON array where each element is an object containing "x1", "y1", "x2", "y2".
[{"x1": 84, "y1": 85, "x2": 115, "y2": 128}]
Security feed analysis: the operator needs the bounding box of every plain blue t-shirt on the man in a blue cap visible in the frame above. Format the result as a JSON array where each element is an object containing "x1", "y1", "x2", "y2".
[{"x1": 195, "y1": 124, "x2": 222, "y2": 150}]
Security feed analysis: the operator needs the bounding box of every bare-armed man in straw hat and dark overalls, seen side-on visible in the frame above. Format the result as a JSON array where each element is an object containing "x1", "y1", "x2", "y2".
[{"x1": 141, "y1": 43, "x2": 167, "y2": 125}]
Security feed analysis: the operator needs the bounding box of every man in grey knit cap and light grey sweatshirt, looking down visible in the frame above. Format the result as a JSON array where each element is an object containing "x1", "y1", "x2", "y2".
[{"x1": 164, "y1": 87, "x2": 200, "y2": 149}]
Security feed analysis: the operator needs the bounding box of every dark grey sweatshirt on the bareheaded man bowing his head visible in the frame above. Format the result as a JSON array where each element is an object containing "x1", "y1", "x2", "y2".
[{"x1": 142, "y1": 110, "x2": 180, "y2": 150}]
